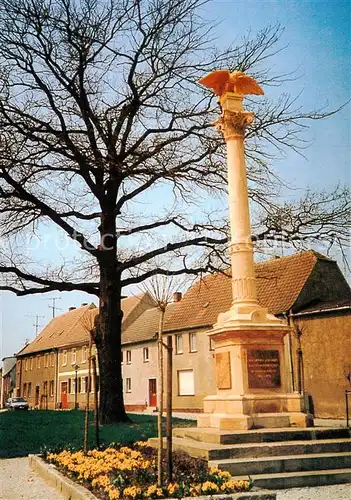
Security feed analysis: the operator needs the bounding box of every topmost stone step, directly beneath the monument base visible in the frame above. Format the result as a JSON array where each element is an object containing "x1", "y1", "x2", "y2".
[{"x1": 173, "y1": 427, "x2": 350, "y2": 444}]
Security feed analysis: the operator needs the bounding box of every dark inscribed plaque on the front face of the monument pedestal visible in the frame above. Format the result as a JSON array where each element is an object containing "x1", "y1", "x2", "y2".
[{"x1": 247, "y1": 349, "x2": 281, "y2": 389}]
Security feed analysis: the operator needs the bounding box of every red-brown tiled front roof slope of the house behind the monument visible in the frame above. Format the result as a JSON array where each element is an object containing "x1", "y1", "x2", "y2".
[{"x1": 165, "y1": 250, "x2": 329, "y2": 330}]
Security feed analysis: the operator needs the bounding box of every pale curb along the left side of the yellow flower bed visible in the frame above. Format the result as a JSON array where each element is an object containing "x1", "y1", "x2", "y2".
[{"x1": 28, "y1": 455, "x2": 97, "y2": 500}]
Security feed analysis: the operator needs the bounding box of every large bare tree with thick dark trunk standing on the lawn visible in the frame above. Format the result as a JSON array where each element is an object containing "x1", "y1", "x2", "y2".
[{"x1": 0, "y1": 0, "x2": 350, "y2": 423}]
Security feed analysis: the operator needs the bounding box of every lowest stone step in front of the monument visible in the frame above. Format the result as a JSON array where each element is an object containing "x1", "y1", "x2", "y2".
[{"x1": 230, "y1": 468, "x2": 351, "y2": 488}]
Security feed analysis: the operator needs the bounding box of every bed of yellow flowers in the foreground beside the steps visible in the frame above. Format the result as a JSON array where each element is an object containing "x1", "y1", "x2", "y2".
[{"x1": 47, "y1": 443, "x2": 252, "y2": 500}]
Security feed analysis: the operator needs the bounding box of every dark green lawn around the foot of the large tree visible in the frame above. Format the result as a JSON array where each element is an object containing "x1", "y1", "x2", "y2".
[{"x1": 0, "y1": 410, "x2": 196, "y2": 458}]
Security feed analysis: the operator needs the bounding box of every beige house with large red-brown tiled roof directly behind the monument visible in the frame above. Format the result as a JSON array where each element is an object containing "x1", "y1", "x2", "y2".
[{"x1": 160, "y1": 251, "x2": 351, "y2": 417}]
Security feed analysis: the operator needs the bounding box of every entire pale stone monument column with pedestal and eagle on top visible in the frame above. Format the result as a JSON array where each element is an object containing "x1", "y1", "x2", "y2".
[{"x1": 198, "y1": 71, "x2": 313, "y2": 430}]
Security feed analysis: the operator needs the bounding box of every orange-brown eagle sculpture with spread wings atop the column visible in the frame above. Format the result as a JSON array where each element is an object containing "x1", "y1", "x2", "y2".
[{"x1": 199, "y1": 69, "x2": 264, "y2": 97}]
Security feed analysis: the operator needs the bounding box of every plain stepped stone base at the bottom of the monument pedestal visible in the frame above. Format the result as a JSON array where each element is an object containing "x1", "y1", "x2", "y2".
[{"x1": 198, "y1": 394, "x2": 313, "y2": 430}]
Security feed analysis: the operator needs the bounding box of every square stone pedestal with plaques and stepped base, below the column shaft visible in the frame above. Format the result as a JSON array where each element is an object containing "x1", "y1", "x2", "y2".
[{"x1": 198, "y1": 305, "x2": 313, "y2": 430}]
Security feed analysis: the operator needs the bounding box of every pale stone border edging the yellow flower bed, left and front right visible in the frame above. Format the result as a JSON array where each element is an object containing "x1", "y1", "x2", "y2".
[{"x1": 28, "y1": 455, "x2": 277, "y2": 500}]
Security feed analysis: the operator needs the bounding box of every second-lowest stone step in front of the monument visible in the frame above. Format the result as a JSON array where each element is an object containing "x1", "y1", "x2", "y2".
[{"x1": 209, "y1": 452, "x2": 351, "y2": 476}]
